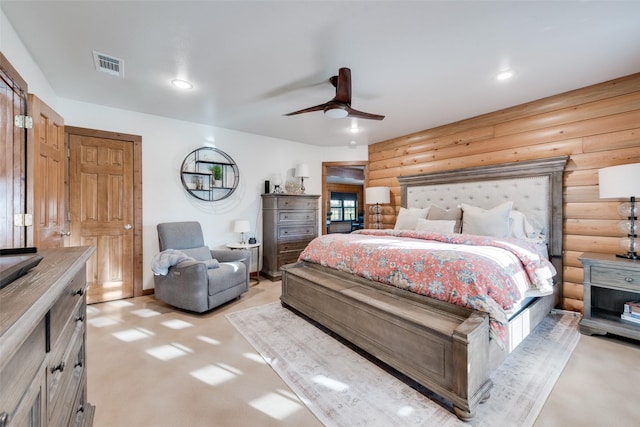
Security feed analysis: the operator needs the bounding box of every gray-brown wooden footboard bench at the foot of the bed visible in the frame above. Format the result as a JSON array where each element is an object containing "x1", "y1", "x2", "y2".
[{"x1": 280, "y1": 262, "x2": 492, "y2": 421}]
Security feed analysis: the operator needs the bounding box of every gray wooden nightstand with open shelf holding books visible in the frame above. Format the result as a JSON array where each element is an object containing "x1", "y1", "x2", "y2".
[{"x1": 578, "y1": 253, "x2": 640, "y2": 340}]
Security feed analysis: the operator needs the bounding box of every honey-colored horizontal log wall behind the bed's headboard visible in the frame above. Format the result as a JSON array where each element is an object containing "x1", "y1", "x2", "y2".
[{"x1": 366, "y1": 73, "x2": 640, "y2": 311}]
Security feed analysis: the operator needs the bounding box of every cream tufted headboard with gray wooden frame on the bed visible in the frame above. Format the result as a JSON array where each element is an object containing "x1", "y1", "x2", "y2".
[{"x1": 398, "y1": 156, "x2": 568, "y2": 263}]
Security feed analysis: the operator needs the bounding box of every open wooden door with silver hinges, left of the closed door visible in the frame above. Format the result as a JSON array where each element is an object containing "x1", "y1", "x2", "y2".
[{"x1": 27, "y1": 94, "x2": 66, "y2": 249}]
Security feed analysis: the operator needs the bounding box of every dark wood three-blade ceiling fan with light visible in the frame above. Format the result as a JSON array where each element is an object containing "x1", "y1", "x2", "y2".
[{"x1": 285, "y1": 68, "x2": 384, "y2": 120}]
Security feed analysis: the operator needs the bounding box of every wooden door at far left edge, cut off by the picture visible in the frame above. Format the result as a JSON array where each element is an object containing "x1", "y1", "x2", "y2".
[{"x1": 0, "y1": 52, "x2": 27, "y2": 248}]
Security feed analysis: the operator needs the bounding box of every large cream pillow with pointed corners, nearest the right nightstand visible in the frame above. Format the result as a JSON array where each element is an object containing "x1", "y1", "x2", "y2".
[{"x1": 460, "y1": 202, "x2": 513, "y2": 237}]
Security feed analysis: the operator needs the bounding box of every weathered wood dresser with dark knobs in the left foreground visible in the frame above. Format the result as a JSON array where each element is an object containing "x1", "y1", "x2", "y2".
[{"x1": 0, "y1": 247, "x2": 95, "y2": 427}]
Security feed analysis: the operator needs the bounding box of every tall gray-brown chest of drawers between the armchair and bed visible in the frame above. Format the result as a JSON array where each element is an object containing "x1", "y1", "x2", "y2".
[{"x1": 261, "y1": 194, "x2": 320, "y2": 281}]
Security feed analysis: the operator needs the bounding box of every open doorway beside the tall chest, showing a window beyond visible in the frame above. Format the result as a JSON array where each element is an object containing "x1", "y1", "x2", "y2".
[{"x1": 321, "y1": 161, "x2": 369, "y2": 234}]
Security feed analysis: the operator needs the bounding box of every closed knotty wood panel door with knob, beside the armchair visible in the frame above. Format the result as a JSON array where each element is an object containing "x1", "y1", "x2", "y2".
[{"x1": 68, "y1": 134, "x2": 134, "y2": 303}]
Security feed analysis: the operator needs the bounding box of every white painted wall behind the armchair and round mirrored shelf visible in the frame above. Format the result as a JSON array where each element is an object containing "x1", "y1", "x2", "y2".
[{"x1": 0, "y1": 10, "x2": 368, "y2": 289}]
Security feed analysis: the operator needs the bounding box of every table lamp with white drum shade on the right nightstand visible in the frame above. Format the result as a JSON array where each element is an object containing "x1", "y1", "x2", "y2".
[{"x1": 598, "y1": 163, "x2": 640, "y2": 259}]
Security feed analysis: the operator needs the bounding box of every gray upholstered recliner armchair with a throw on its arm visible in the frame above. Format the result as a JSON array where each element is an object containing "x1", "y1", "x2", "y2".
[{"x1": 154, "y1": 221, "x2": 250, "y2": 313}]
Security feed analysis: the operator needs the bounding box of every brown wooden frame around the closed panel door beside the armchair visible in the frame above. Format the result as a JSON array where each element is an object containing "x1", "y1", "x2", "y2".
[{"x1": 64, "y1": 126, "x2": 145, "y2": 297}]
